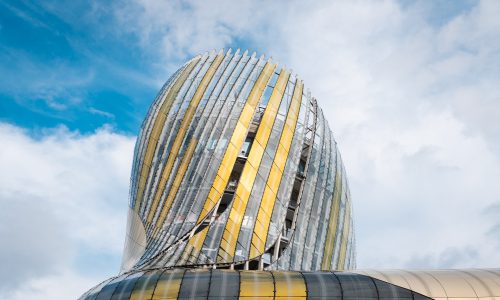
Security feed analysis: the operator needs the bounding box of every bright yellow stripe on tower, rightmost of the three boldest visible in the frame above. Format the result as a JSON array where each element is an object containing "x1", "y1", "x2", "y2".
[{"x1": 250, "y1": 81, "x2": 303, "y2": 259}]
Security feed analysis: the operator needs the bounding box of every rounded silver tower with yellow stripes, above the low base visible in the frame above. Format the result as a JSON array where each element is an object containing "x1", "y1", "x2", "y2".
[{"x1": 122, "y1": 50, "x2": 355, "y2": 271}]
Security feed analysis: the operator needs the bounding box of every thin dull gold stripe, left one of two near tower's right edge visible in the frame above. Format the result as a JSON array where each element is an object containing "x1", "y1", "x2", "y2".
[{"x1": 321, "y1": 163, "x2": 342, "y2": 271}]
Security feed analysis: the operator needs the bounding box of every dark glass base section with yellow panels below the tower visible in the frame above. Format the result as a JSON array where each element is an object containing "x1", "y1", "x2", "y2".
[{"x1": 82, "y1": 269, "x2": 430, "y2": 300}]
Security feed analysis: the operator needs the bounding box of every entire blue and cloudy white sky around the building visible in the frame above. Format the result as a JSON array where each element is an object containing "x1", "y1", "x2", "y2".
[{"x1": 0, "y1": 0, "x2": 500, "y2": 299}]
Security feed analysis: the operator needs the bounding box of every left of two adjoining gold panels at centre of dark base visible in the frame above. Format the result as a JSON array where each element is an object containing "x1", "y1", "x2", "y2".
[{"x1": 240, "y1": 271, "x2": 274, "y2": 299}]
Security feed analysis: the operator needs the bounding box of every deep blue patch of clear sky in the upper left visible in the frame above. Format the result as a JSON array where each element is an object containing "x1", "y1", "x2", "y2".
[{"x1": 0, "y1": 1, "x2": 158, "y2": 134}]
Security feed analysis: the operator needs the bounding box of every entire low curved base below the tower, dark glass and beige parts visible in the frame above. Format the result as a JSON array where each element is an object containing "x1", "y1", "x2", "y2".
[{"x1": 82, "y1": 269, "x2": 500, "y2": 300}]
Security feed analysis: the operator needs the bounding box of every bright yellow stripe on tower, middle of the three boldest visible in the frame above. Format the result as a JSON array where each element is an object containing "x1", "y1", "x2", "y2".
[{"x1": 219, "y1": 70, "x2": 290, "y2": 262}]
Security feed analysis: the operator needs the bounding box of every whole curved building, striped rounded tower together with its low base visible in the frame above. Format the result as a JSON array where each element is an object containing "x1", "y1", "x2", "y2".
[{"x1": 82, "y1": 50, "x2": 500, "y2": 299}]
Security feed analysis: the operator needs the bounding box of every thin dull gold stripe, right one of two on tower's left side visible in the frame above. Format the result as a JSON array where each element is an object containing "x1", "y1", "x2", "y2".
[{"x1": 147, "y1": 54, "x2": 224, "y2": 223}]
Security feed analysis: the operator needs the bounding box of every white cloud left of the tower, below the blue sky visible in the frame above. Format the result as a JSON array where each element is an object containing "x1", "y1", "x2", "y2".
[{"x1": 0, "y1": 123, "x2": 134, "y2": 299}]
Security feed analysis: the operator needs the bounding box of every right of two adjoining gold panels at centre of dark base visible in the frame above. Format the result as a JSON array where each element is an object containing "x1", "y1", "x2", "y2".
[{"x1": 273, "y1": 271, "x2": 307, "y2": 299}]
